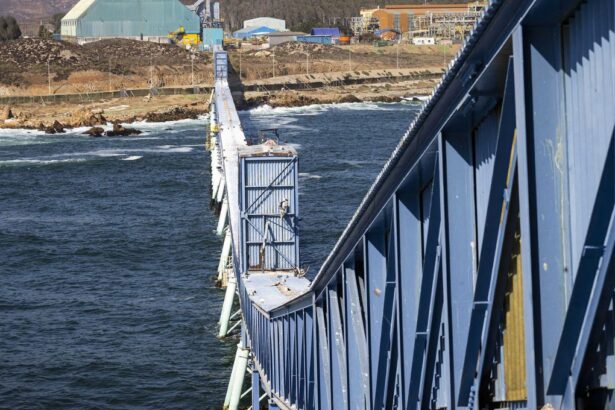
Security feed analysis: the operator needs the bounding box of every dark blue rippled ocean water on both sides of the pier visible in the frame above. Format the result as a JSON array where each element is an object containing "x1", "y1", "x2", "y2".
[{"x1": 0, "y1": 104, "x2": 418, "y2": 409}]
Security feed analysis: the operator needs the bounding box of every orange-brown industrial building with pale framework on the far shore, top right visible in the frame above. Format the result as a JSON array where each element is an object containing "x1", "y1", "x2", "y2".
[{"x1": 351, "y1": 2, "x2": 484, "y2": 40}]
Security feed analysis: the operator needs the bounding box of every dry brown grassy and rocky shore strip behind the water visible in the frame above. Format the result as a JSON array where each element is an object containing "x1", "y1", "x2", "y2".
[{"x1": 0, "y1": 39, "x2": 454, "y2": 136}]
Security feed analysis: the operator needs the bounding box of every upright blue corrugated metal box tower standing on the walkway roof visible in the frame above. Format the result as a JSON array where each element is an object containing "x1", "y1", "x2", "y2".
[{"x1": 239, "y1": 140, "x2": 299, "y2": 272}]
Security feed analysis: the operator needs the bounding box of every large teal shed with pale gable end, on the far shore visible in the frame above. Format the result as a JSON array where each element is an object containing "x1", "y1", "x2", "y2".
[{"x1": 61, "y1": 0, "x2": 201, "y2": 44}]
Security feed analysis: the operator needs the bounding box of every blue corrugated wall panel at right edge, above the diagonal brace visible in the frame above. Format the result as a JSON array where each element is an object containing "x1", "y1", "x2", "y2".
[{"x1": 564, "y1": 0, "x2": 615, "y2": 278}]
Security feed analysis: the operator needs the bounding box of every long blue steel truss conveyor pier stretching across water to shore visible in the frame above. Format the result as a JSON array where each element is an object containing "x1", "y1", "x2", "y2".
[{"x1": 208, "y1": 0, "x2": 615, "y2": 410}]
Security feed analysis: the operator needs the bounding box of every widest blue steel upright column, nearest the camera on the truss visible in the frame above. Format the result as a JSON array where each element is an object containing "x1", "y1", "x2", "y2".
[{"x1": 514, "y1": 22, "x2": 571, "y2": 407}]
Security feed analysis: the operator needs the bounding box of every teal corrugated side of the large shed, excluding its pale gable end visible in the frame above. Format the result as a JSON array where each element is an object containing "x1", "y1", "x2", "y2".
[{"x1": 76, "y1": 0, "x2": 201, "y2": 37}]
